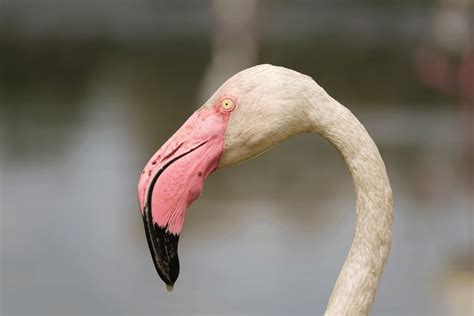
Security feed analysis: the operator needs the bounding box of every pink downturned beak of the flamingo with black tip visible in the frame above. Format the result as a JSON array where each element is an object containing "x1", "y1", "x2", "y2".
[{"x1": 138, "y1": 102, "x2": 230, "y2": 286}]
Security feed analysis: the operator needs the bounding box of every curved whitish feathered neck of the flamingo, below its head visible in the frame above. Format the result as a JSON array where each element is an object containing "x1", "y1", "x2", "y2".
[{"x1": 308, "y1": 85, "x2": 392, "y2": 315}]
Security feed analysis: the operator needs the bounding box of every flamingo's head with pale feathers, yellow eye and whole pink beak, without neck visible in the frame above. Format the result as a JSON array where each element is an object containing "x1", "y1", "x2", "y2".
[{"x1": 138, "y1": 65, "x2": 314, "y2": 289}]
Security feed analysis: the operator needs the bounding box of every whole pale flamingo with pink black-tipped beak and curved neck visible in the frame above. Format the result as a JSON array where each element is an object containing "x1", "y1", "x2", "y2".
[{"x1": 138, "y1": 64, "x2": 392, "y2": 315}]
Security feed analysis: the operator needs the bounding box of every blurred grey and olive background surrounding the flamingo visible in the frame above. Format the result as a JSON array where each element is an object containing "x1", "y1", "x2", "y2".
[{"x1": 0, "y1": 0, "x2": 474, "y2": 315}]
